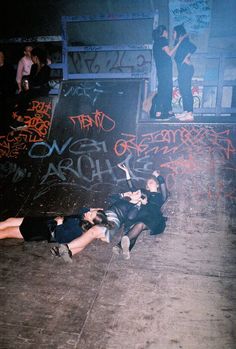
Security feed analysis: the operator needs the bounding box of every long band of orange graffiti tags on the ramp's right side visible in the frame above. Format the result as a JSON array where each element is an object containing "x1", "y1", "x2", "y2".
[{"x1": 114, "y1": 126, "x2": 236, "y2": 159}]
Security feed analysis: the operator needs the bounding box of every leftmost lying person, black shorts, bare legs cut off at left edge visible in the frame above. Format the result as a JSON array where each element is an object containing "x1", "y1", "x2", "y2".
[{"x1": 0, "y1": 207, "x2": 98, "y2": 243}]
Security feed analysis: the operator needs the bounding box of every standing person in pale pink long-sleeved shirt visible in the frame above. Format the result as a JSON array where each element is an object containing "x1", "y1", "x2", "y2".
[{"x1": 16, "y1": 46, "x2": 33, "y2": 93}]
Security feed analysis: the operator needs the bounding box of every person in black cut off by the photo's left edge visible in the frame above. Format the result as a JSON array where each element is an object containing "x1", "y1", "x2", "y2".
[{"x1": 0, "y1": 50, "x2": 17, "y2": 134}]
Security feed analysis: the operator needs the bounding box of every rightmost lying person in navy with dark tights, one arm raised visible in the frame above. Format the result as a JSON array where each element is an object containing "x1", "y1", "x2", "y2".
[{"x1": 113, "y1": 165, "x2": 168, "y2": 259}]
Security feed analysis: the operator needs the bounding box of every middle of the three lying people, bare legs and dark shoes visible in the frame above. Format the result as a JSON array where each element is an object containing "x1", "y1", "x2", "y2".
[{"x1": 51, "y1": 190, "x2": 147, "y2": 262}]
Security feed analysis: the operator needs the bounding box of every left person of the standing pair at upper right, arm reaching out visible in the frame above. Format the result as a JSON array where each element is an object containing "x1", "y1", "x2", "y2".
[{"x1": 150, "y1": 25, "x2": 185, "y2": 119}]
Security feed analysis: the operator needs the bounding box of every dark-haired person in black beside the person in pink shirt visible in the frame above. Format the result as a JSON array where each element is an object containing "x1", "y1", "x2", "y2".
[{"x1": 12, "y1": 47, "x2": 51, "y2": 127}]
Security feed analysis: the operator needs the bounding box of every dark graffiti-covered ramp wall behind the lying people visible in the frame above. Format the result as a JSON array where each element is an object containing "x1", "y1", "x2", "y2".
[{"x1": 0, "y1": 80, "x2": 236, "y2": 215}]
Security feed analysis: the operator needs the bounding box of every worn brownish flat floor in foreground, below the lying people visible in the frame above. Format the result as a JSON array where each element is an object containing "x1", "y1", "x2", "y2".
[{"x1": 0, "y1": 201, "x2": 236, "y2": 349}]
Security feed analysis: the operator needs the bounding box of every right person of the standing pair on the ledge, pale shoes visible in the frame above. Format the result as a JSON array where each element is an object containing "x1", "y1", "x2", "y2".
[{"x1": 173, "y1": 25, "x2": 197, "y2": 121}]
